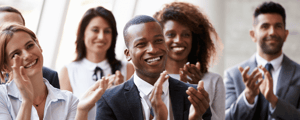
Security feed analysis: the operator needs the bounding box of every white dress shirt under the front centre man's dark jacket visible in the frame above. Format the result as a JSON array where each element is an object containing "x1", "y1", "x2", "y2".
[{"x1": 133, "y1": 73, "x2": 173, "y2": 120}]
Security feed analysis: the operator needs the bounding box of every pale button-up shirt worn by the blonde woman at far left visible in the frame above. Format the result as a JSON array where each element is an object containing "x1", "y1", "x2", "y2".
[{"x1": 0, "y1": 79, "x2": 78, "y2": 120}]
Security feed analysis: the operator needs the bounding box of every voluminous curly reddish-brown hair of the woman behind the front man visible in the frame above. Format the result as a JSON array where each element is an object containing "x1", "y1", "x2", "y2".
[{"x1": 153, "y1": 2, "x2": 222, "y2": 73}]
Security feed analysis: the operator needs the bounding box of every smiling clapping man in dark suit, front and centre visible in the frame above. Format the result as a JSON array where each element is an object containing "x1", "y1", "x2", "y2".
[{"x1": 96, "y1": 15, "x2": 211, "y2": 120}]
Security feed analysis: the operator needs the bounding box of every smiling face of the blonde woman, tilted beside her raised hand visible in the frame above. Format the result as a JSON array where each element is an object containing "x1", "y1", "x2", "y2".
[{"x1": 6, "y1": 31, "x2": 43, "y2": 77}]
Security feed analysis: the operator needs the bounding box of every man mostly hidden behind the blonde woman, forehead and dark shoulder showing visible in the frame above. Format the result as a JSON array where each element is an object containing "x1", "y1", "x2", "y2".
[{"x1": 0, "y1": 6, "x2": 60, "y2": 89}]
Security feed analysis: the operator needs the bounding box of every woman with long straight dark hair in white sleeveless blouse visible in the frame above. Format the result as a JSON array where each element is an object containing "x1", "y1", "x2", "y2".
[{"x1": 59, "y1": 6, "x2": 134, "y2": 119}]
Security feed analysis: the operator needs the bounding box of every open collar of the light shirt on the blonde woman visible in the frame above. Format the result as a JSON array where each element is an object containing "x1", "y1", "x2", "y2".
[{"x1": 7, "y1": 78, "x2": 65, "y2": 101}]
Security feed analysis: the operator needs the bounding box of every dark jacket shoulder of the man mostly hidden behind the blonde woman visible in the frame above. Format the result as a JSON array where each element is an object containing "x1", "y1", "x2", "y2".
[{"x1": 43, "y1": 67, "x2": 60, "y2": 89}]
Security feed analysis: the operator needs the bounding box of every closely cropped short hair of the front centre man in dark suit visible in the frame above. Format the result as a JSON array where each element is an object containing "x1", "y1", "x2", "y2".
[{"x1": 123, "y1": 15, "x2": 160, "y2": 48}]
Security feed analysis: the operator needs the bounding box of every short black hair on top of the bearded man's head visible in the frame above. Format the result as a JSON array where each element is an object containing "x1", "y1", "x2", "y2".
[{"x1": 253, "y1": 1, "x2": 286, "y2": 26}]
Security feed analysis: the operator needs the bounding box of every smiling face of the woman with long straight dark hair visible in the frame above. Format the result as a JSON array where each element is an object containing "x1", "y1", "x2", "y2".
[{"x1": 84, "y1": 16, "x2": 112, "y2": 54}]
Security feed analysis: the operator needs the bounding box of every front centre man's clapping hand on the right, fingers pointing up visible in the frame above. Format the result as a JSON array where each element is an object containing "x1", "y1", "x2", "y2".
[{"x1": 186, "y1": 81, "x2": 210, "y2": 120}]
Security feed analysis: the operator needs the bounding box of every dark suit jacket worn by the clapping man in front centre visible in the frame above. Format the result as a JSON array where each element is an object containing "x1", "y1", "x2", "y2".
[{"x1": 96, "y1": 77, "x2": 211, "y2": 120}]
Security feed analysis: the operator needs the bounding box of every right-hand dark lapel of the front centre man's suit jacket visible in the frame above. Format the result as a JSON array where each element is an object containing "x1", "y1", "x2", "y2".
[{"x1": 169, "y1": 77, "x2": 184, "y2": 120}]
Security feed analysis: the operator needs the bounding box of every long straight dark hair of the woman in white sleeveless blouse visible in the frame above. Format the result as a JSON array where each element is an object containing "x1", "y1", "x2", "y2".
[{"x1": 74, "y1": 6, "x2": 122, "y2": 74}]
